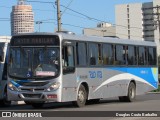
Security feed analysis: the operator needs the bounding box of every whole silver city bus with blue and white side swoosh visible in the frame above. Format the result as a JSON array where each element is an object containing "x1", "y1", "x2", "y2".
[{"x1": 7, "y1": 33, "x2": 158, "y2": 108}]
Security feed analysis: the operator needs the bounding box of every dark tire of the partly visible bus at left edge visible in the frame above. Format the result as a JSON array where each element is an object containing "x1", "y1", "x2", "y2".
[{"x1": 0, "y1": 89, "x2": 11, "y2": 107}]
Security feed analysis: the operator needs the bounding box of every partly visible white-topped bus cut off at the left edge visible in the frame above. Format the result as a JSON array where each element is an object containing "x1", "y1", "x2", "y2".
[{"x1": 0, "y1": 36, "x2": 11, "y2": 106}]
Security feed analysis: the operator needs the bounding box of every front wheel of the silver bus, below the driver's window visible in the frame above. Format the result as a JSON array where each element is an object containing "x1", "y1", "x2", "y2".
[{"x1": 73, "y1": 85, "x2": 87, "y2": 107}]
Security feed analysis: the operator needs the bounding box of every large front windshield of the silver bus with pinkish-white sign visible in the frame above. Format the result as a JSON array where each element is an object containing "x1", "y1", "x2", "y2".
[{"x1": 9, "y1": 47, "x2": 60, "y2": 78}]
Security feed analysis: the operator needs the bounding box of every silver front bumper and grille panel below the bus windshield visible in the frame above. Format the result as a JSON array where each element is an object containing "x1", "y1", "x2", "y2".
[{"x1": 8, "y1": 76, "x2": 62, "y2": 102}]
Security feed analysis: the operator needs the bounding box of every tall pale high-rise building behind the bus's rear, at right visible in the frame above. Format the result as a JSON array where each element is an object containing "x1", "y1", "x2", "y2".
[{"x1": 115, "y1": 0, "x2": 160, "y2": 54}]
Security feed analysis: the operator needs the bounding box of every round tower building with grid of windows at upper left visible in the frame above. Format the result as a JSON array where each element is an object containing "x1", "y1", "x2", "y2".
[{"x1": 11, "y1": 0, "x2": 34, "y2": 35}]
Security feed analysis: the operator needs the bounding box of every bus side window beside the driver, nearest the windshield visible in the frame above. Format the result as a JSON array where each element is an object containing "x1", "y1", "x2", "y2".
[{"x1": 62, "y1": 46, "x2": 75, "y2": 74}]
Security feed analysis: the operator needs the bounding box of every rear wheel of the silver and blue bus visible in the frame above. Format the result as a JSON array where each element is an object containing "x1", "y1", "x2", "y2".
[{"x1": 126, "y1": 82, "x2": 136, "y2": 102}]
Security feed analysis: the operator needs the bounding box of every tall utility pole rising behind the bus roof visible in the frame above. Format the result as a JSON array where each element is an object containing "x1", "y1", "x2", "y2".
[{"x1": 56, "y1": 0, "x2": 61, "y2": 32}]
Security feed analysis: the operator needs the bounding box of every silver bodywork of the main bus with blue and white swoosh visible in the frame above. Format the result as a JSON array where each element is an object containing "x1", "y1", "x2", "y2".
[{"x1": 8, "y1": 34, "x2": 158, "y2": 102}]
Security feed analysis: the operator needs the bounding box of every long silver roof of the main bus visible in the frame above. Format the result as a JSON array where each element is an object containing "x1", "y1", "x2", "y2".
[{"x1": 13, "y1": 32, "x2": 156, "y2": 46}]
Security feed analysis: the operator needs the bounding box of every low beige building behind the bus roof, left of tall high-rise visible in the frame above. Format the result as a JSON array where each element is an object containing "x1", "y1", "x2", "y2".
[{"x1": 83, "y1": 23, "x2": 116, "y2": 37}]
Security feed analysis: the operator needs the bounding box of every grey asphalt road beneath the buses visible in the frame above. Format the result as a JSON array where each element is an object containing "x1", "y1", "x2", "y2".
[{"x1": 0, "y1": 93, "x2": 160, "y2": 111}]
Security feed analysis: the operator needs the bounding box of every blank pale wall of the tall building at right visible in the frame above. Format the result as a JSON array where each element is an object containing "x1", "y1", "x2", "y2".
[{"x1": 116, "y1": 4, "x2": 143, "y2": 40}]
